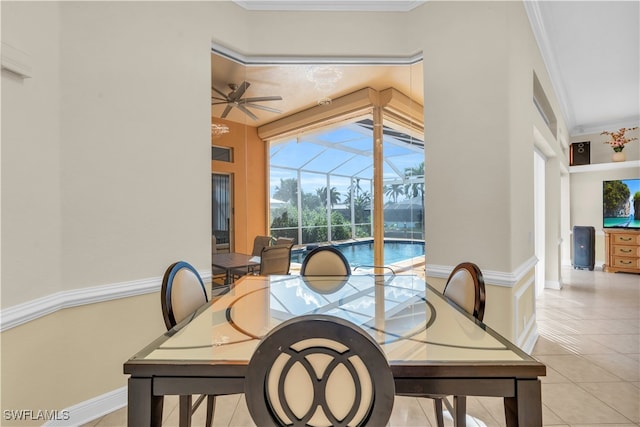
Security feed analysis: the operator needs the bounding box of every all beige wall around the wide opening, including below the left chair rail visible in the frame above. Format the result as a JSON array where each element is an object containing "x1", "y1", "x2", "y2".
[{"x1": 1, "y1": 2, "x2": 568, "y2": 422}]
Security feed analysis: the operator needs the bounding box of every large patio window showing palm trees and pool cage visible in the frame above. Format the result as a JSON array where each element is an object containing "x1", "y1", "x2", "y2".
[{"x1": 270, "y1": 115, "x2": 424, "y2": 249}]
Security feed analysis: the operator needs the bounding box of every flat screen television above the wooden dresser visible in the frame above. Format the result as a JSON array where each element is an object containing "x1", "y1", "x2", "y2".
[{"x1": 602, "y1": 178, "x2": 640, "y2": 229}]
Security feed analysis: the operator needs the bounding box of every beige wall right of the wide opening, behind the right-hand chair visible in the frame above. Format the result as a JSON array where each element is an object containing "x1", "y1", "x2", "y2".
[{"x1": 413, "y1": 2, "x2": 567, "y2": 342}]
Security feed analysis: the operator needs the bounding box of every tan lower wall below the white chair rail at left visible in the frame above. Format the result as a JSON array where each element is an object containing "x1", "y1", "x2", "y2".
[{"x1": 1, "y1": 293, "x2": 166, "y2": 425}]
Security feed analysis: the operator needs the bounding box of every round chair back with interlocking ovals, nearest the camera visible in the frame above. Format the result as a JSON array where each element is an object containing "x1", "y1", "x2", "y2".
[{"x1": 245, "y1": 315, "x2": 395, "y2": 426}]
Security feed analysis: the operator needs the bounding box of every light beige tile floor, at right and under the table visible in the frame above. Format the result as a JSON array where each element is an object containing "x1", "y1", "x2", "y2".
[{"x1": 82, "y1": 268, "x2": 640, "y2": 427}]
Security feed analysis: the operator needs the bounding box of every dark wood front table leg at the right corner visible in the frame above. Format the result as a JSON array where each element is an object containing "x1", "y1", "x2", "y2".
[{"x1": 504, "y1": 380, "x2": 542, "y2": 427}]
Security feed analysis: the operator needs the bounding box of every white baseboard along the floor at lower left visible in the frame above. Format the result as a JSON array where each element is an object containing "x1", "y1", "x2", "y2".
[{"x1": 43, "y1": 387, "x2": 127, "y2": 427}]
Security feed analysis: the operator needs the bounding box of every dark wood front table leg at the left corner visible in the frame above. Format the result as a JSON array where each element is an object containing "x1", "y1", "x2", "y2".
[{"x1": 127, "y1": 377, "x2": 164, "y2": 427}]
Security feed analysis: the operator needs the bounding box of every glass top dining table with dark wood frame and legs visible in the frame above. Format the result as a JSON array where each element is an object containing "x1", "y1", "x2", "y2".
[{"x1": 124, "y1": 275, "x2": 546, "y2": 426}]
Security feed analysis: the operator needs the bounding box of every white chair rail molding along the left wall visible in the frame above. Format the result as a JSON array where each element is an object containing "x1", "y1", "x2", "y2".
[{"x1": 0, "y1": 270, "x2": 211, "y2": 332}]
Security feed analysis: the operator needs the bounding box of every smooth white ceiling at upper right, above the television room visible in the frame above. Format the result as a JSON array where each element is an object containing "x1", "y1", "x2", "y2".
[{"x1": 525, "y1": 1, "x2": 640, "y2": 136}]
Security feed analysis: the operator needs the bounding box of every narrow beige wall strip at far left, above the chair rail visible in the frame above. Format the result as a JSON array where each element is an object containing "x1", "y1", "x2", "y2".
[{"x1": 0, "y1": 2, "x2": 63, "y2": 308}]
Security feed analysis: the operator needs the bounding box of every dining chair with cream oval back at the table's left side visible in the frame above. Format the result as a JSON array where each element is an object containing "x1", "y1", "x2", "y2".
[{"x1": 160, "y1": 261, "x2": 216, "y2": 427}]
